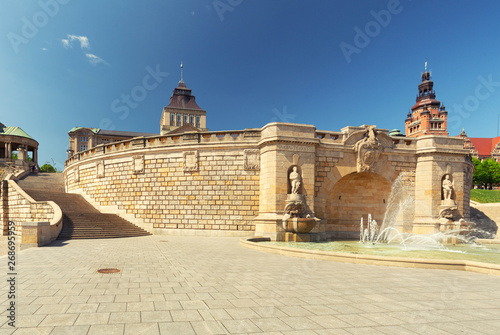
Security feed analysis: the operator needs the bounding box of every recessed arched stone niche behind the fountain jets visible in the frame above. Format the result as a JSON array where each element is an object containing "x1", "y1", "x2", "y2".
[{"x1": 324, "y1": 172, "x2": 391, "y2": 239}]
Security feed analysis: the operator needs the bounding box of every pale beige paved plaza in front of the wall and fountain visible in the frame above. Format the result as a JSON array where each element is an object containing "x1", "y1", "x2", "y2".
[{"x1": 0, "y1": 236, "x2": 500, "y2": 335}]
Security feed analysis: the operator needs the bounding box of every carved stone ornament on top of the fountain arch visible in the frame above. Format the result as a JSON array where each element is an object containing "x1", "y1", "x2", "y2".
[{"x1": 354, "y1": 126, "x2": 383, "y2": 172}]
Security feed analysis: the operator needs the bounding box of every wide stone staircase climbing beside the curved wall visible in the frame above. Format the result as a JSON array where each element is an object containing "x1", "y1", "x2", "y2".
[{"x1": 17, "y1": 173, "x2": 150, "y2": 240}]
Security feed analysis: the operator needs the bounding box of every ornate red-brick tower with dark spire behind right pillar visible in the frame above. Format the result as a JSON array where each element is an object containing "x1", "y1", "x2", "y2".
[{"x1": 405, "y1": 62, "x2": 448, "y2": 137}]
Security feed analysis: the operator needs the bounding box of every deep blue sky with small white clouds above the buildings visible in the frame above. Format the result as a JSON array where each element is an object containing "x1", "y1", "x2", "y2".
[{"x1": 0, "y1": 0, "x2": 500, "y2": 169}]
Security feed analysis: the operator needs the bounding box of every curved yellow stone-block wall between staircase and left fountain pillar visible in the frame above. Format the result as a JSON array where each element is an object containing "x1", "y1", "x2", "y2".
[{"x1": 64, "y1": 131, "x2": 260, "y2": 235}]
